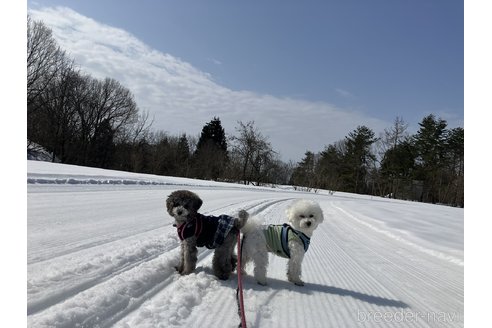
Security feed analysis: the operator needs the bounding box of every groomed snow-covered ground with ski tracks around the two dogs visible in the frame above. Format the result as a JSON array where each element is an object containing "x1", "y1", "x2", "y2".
[{"x1": 27, "y1": 161, "x2": 464, "y2": 328}]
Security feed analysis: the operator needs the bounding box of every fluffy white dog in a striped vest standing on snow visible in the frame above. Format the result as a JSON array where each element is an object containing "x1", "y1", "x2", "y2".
[{"x1": 241, "y1": 199, "x2": 324, "y2": 286}]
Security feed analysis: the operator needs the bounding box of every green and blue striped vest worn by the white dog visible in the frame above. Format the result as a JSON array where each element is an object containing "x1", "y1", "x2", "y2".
[{"x1": 263, "y1": 223, "x2": 311, "y2": 258}]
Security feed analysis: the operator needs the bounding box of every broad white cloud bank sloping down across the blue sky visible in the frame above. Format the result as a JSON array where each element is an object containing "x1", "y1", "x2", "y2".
[{"x1": 29, "y1": 7, "x2": 391, "y2": 161}]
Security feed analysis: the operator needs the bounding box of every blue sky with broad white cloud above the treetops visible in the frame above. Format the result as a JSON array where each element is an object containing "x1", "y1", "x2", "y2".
[{"x1": 28, "y1": 0, "x2": 464, "y2": 160}]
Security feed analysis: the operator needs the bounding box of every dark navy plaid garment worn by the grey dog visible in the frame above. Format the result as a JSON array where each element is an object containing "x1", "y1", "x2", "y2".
[{"x1": 177, "y1": 213, "x2": 235, "y2": 249}]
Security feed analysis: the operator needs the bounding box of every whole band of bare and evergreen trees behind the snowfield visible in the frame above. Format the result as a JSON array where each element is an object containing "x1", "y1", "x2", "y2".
[{"x1": 27, "y1": 17, "x2": 464, "y2": 207}]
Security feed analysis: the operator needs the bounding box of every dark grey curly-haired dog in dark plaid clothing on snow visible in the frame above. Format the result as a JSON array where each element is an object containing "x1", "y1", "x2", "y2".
[{"x1": 166, "y1": 190, "x2": 249, "y2": 280}]
